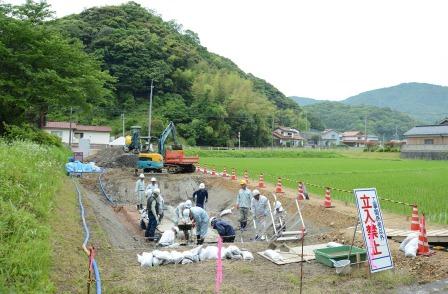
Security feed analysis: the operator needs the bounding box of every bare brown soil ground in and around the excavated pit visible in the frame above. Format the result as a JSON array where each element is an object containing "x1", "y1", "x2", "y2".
[{"x1": 73, "y1": 168, "x2": 448, "y2": 293}]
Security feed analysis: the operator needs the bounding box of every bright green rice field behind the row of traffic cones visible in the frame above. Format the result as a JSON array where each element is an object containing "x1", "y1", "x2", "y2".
[{"x1": 200, "y1": 154, "x2": 448, "y2": 224}]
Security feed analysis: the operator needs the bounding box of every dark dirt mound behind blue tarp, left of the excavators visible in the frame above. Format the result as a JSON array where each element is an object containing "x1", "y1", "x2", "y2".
[{"x1": 87, "y1": 147, "x2": 138, "y2": 168}]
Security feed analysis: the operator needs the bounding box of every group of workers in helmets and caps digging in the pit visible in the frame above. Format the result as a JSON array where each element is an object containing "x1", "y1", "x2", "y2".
[{"x1": 135, "y1": 174, "x2": 285, "y2": 245}]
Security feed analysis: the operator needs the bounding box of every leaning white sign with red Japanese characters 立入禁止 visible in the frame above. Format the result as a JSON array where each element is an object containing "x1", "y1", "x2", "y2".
[{"x1": 353, "y1": 188, "x2": 394, "y2": 273}]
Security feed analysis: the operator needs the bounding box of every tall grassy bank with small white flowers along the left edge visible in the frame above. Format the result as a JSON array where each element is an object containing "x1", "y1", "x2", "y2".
[{"x1": 0, "y1": 140, "x2": 67, "y2": 293}]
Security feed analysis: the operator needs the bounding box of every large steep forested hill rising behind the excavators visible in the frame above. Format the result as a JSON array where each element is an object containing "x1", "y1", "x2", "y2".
[{"x1": 49, "y1": 2, "x2": 304, "y2": 146}]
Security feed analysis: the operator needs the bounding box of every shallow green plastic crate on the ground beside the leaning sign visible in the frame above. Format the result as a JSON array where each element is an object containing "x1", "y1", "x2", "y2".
[{"x1": 314, "y1": 245, "x2": 367, "y2": 267}]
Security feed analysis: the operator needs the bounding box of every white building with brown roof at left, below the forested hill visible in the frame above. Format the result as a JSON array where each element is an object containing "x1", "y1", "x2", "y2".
[{"x1": 42, "y1": 121, "x2": 112, "y2": 147}]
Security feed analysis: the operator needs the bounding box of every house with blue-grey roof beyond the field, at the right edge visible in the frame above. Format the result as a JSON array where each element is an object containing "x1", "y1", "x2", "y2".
[{"x1": 401, "y1": 118, "x2": 448, "y2": 159}]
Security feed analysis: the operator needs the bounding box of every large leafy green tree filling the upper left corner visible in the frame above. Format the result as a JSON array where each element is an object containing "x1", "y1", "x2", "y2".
[{"x1": 0, "y1": 1, "x2": 113, "y2": 130}]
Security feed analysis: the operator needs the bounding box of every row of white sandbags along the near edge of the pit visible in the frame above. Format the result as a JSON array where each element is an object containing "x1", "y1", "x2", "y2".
[{"x1": 137, "y1": 245, "x2": 254, "y2": 267}]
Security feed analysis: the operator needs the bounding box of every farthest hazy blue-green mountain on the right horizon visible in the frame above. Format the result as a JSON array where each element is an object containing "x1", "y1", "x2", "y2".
[{"x1": 342, "y1": 83, "x2": 448, "y2": 123}]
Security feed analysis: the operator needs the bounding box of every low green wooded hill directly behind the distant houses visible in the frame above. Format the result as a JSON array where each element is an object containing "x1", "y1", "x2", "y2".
[{"x1": 304, "y1": 101, "x2": 421, "y2": 139}]
